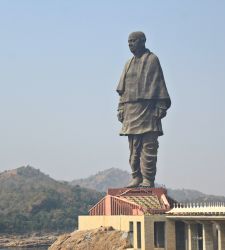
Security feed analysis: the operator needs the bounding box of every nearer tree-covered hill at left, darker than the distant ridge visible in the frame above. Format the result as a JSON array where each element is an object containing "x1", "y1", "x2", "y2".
[{"x1": 0, "y1": 166, "x2": 102, "y2": 233}]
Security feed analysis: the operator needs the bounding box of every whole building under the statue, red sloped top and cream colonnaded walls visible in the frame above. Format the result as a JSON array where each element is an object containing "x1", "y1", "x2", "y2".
[{"x1": 79, "y1": 188, "x2": 225, "y2": 250}]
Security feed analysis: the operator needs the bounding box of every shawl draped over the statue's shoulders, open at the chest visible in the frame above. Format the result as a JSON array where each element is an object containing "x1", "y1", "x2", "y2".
[{"x1": 116, "y1": 50, "x2": 171, "y2": 108}]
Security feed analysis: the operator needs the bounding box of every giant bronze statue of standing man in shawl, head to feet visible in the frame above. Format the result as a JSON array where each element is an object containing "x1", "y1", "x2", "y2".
[{"x1": 117, "y1": 32, "x2": 171, "y2": 188}]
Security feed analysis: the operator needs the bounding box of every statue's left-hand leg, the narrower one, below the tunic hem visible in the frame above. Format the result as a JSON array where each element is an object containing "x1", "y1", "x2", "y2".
[{"x1": 127, "y1": 135, "x2": 142, "y2": 187}]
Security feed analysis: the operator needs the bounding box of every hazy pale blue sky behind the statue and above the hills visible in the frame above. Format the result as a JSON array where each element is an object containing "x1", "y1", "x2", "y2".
[{"x1": 0, "y1": 0, "x2": 225, "y2": 195}]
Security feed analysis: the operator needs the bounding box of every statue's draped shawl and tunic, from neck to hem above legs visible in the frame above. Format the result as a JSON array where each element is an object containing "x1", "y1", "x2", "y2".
[{"x1": 117, "y1": 49, "x2": 171, "y2": 135}]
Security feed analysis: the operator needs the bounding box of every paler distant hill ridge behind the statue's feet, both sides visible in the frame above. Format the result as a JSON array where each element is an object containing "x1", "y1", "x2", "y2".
[{"x1": 70, "y1": 168, "x2": 225, "y2": 202}]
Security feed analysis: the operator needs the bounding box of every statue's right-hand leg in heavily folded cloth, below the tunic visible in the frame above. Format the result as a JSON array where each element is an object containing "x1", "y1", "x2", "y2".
[{"x1": 140, "y1": 132, "x2": 159, "y2": 187}]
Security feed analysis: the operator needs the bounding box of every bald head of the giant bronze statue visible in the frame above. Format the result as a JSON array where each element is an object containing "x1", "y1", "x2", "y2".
[{"x1": 128, "y1": 31, "x2": 146, "y2": 56}]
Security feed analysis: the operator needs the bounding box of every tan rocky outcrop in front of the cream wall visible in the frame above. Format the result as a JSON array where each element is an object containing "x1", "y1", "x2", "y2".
[{"x1": 48, "y1": 227, "x2": 131, "y2": 250}]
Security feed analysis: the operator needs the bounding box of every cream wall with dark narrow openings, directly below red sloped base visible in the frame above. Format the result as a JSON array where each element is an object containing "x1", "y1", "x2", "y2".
[{"x1": 79, "y1": 215, "x2": 176, "y2": 250}]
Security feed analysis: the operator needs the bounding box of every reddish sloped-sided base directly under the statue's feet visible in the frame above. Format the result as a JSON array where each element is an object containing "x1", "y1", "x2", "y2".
[{"x1": 89, "y1": 187, "x2": 175, "y2": 215}]
